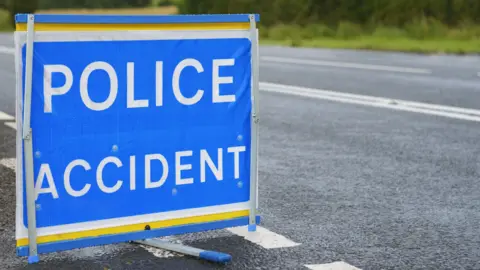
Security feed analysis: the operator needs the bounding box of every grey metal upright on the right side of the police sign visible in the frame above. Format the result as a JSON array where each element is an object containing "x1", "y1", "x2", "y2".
[{"x1": 248, "y1": 14, "x2": 259, "y2": 231}]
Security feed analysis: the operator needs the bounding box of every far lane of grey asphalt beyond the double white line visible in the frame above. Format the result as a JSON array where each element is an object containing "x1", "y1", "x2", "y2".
[{"x1": 260, "y1": 47, "x2": 480, "y2": 109}]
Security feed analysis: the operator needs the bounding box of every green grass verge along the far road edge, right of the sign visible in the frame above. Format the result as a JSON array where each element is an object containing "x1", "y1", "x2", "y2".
[{"x1": 260, "y1": 20, "x2": 480, "y2": 54}]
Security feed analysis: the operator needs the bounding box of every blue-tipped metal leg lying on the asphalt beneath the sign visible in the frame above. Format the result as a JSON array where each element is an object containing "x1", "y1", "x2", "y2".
[{"x1": 134, "y1": 239, "x2": 232, "y2": 263}]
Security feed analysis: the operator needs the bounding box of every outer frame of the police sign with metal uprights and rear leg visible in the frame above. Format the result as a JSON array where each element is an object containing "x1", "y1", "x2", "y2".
[{"x1": 15, "y1": 14, "x2": 260, "y2": 263}]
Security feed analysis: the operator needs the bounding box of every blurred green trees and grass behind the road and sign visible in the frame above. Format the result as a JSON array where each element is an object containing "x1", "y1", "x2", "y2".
[{"x1": 0, "y1": 0, "x2": 480, "y2": 53}]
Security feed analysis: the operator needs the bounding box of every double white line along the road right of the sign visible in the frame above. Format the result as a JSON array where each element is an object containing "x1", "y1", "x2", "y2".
[{"x1": 260, "y1": 83, "x2": 480, "y2": 122}]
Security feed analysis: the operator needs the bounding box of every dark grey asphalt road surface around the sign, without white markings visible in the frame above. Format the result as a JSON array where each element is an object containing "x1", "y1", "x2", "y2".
[{"x1": 0, "y1": 32, "x2": 480, "y2": 270}]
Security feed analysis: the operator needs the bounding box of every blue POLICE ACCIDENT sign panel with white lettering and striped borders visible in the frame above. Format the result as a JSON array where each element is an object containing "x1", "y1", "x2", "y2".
[{"x1": 15, "y1": 15, "x2": 258, "y2": 255}]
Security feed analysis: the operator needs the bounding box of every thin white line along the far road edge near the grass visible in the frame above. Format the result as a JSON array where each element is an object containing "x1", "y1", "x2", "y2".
[{"x1": 260, "y1": 56, "x2": 432, "y2": 74}]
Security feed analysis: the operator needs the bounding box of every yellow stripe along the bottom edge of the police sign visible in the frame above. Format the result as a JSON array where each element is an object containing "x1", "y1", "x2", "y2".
[{"x1": 17, "y1": 210, "x2": 249, "y2": 247}]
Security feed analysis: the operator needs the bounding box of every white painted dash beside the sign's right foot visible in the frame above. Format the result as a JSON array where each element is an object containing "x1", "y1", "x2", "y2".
[{"x1": 227, "y1": 226, "x2": 300, "y2": 249}]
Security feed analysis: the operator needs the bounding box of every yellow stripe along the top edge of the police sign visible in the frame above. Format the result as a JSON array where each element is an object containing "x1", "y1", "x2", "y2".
[{"x1": 16, "y1": 23, "x2": 250, "y2": 31}]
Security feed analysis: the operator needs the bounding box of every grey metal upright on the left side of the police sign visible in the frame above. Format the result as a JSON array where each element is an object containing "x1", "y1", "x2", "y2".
[{"x1": 22, "y1": 14, "x2": 39, "y2": 264}]
